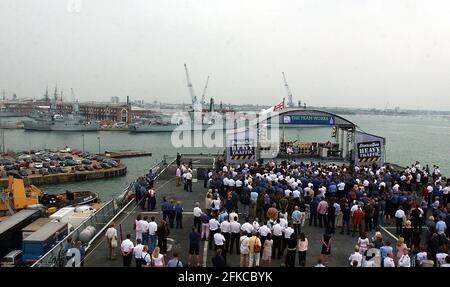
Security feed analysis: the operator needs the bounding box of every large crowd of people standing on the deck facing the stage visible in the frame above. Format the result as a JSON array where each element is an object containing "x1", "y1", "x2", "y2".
[{"x1": 107, "y1": 153, "x2": 450, "y2": 267}]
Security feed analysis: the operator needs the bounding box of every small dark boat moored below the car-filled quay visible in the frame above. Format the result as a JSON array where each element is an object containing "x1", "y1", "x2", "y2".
[{"x1": 40, "y1": 190, "x2": 100, "y2": 209}]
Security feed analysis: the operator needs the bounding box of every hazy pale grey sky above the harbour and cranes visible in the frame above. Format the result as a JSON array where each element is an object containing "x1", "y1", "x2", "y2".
[{"x1": 0, "y1": 0, "x2": 450, "y2": 110}]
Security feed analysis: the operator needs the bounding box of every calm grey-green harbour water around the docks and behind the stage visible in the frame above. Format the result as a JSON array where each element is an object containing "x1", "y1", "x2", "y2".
[{"x1": 1, "y1": 115, "x2": 450, "y2": 200}]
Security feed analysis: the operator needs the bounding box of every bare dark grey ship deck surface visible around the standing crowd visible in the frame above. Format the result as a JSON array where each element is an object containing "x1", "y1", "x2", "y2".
[{"x1": 84, "y1": 155, "x2": 394, "y2": 267}]
